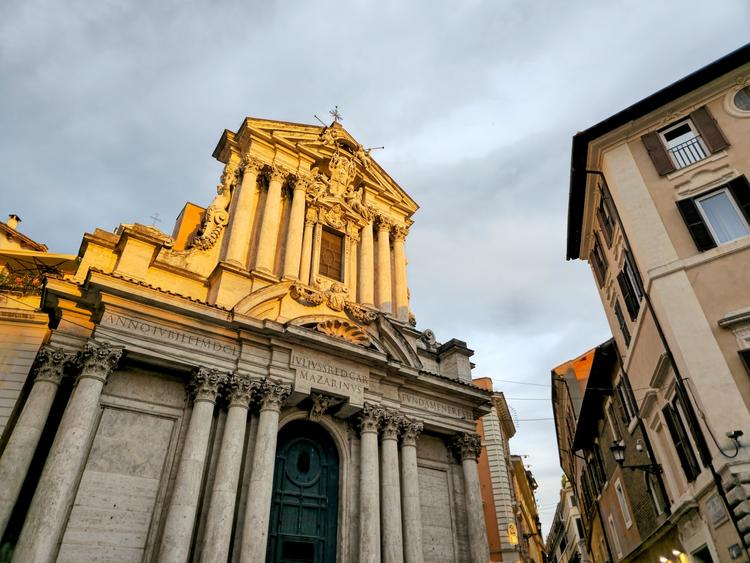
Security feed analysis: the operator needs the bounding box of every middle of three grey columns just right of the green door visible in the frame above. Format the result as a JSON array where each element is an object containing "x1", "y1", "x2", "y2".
[{"x1": 380, "y1": 412, "x2": 404, "y2": 563}]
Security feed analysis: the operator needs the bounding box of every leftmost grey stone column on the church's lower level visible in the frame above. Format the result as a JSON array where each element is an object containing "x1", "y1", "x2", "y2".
[{"x1": 0, "y1": 346, "x2": 74, "y2": 537}]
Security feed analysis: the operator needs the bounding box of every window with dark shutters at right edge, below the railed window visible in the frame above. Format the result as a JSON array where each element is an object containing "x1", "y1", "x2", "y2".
[{"x1": 677, "y1": 176, "x2": 750, "y2": 252}]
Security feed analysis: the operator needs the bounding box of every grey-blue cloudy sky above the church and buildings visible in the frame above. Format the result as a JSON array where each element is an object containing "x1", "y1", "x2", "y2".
[{"x1": 0, "y1": 0, "x2": 750, "y2": 532}]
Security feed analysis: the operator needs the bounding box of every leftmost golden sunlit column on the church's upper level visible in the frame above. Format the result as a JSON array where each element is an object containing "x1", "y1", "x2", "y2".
[{"x1": 226, "y1": 154, "x2": 263, "y2": 268}]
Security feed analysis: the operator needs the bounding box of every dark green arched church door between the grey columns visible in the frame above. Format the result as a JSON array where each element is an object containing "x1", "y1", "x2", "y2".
[{"x1": 266, "y1": 420, "x2": 339, "y2": 563}]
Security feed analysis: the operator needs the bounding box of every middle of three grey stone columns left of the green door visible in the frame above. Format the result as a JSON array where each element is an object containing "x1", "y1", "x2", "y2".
[{"x1": 201, "y1": 374, "x2": 258, "y2": 563}]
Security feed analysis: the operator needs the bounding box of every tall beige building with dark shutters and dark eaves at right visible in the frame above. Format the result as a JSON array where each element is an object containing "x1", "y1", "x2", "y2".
[{"x1": 568, "y1": 46, "x2": 750, "y2": 561}]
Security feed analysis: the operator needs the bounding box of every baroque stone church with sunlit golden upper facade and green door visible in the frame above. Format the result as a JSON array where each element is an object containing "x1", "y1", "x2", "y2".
[{"x1": 0, "y1": 118, "x2": 490, "y2": 563}]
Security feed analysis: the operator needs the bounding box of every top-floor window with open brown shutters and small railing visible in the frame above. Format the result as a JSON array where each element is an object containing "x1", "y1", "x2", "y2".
[{"x1": 641, "y1": 106, "x2": 729, "y2": 176}]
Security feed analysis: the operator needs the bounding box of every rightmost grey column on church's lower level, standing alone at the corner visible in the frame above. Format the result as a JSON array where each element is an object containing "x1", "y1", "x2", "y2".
[{"x1": 453, "y1": 434, "x2": 490, "y2": 563}]
